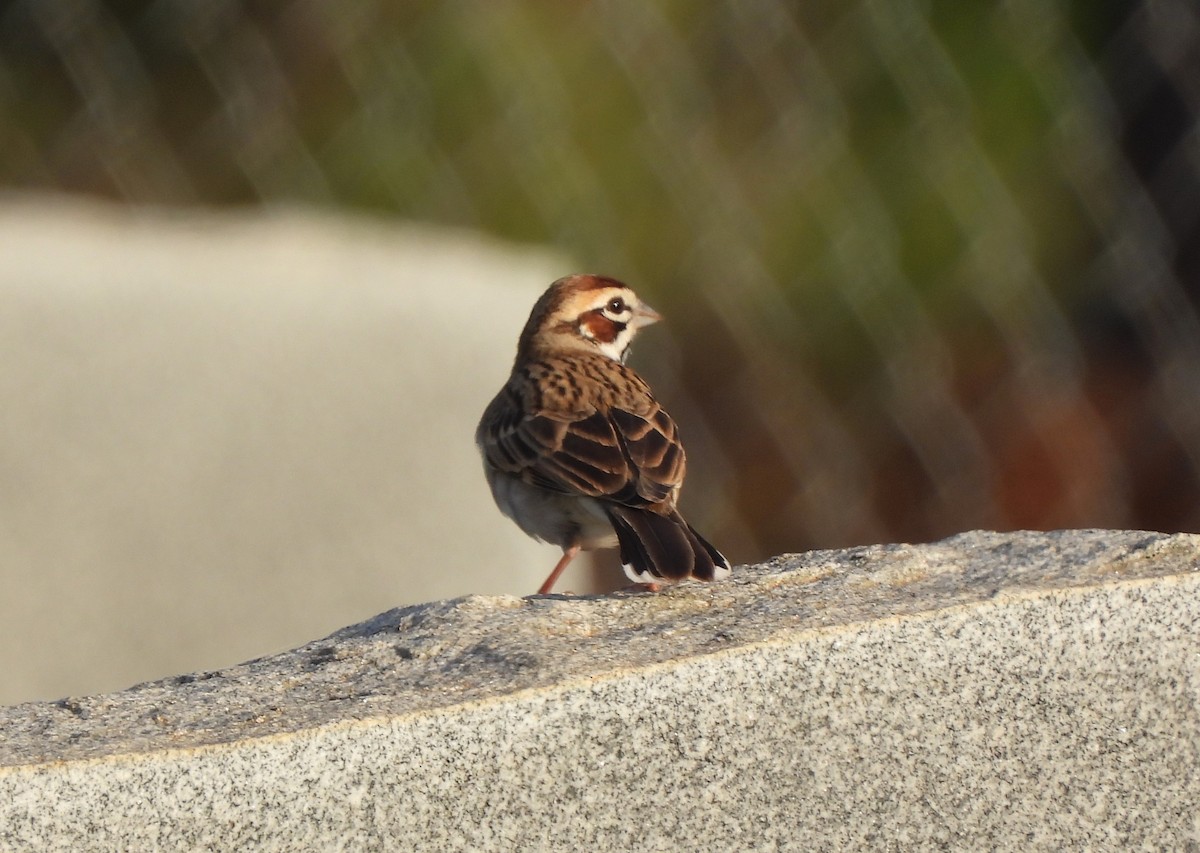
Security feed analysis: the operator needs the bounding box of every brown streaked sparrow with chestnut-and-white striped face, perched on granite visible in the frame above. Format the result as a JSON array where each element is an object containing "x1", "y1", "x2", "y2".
[{"x1": 475, "y1": 275, "x2": 731, "y2": 595}]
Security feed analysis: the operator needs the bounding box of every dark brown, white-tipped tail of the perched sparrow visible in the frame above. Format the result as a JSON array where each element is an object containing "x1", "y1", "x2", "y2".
[{"x1": 605, "y1": 506, "x2": 730, "y2": 583}]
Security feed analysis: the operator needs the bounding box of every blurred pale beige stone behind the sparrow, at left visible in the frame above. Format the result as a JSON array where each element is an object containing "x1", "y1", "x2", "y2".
[{"x1": 0, "y1": 197, "x2": 582, "y2": 703}]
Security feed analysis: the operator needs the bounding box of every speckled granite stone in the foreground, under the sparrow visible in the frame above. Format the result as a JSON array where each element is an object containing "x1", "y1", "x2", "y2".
[{"x1": 0, "y1": 531, "x2": 1200, "y2": 851}]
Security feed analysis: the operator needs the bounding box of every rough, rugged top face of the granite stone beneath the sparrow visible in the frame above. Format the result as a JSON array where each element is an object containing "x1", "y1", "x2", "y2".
[{"x1": 0, "y1": 530, "x2": 1200, "y2": 771}]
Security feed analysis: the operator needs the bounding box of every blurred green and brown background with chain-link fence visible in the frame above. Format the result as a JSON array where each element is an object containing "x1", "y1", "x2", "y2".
[{"x1": 0, "y1": 0, "x2": 1200, "y2": 705}]
